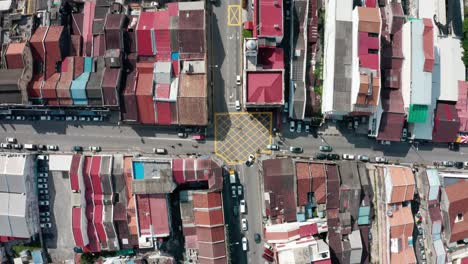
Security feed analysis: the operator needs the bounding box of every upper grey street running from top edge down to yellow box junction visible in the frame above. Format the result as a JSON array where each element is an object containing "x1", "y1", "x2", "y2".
[{"x1": 210, "y1": 0, "x2": 241, "y2": 113}]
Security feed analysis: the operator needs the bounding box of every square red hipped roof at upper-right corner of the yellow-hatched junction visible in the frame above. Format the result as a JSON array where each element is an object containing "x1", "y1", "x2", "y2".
[{"x1": 247, "y1": 71, "x2": 283, "y2": 104}]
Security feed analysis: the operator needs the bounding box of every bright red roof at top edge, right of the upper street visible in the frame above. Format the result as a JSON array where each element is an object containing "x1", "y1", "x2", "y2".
[{"x1": 258, "y1": 0, "x2": 284, "y2": 38}]
